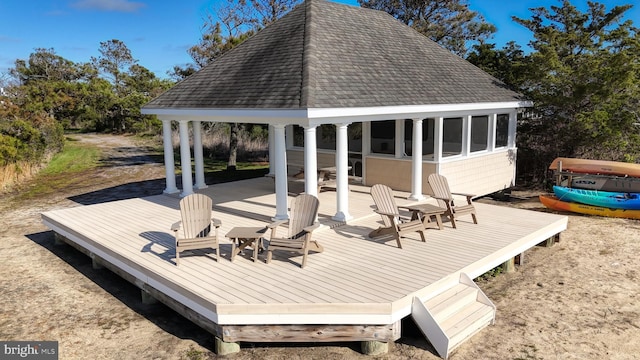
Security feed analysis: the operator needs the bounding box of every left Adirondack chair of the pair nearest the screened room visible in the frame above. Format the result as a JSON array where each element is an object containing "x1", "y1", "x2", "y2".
[{"x1": 369, "y1": 184, "x2": 426, "y2": 249}]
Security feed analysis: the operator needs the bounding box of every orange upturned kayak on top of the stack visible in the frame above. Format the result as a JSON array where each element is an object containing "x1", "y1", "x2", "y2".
[{"x1": 549, "y1": 157, "x2": 640, "y2": 177}]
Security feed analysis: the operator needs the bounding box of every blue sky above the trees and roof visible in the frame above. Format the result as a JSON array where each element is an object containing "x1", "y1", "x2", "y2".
[{"x1": 0, "y1": 0, "x2": 640, "y2": 78}]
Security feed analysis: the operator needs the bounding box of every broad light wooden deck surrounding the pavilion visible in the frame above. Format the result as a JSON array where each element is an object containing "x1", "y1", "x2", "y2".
[{"x1": 42, "y1": 178, "x2": 567, "y2": 341}]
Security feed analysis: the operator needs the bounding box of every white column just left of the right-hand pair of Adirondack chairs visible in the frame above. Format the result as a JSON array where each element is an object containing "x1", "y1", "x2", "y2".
[{"x1": 333, "y1": 124, "x2": 352, "y2": 221}]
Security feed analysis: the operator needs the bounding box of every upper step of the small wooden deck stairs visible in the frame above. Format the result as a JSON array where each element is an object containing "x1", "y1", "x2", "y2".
[{"x1": 424, "y1": 283, "x2": 478, "y2": 323}]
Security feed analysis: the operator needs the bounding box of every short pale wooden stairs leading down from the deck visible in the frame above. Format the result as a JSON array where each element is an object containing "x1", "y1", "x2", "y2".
[{"x1": 411, "y1": 273, "x2": 496, "y2": 359}]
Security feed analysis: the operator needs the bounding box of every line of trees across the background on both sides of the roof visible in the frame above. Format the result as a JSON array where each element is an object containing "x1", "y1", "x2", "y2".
[{"x1": 0, "y1": 0, "x2": 640, "y2": 188}]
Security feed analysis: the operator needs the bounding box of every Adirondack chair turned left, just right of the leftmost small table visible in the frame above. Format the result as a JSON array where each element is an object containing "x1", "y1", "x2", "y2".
[{"x1": 266, "y1": 194, "x2": 324, "y2": 267}]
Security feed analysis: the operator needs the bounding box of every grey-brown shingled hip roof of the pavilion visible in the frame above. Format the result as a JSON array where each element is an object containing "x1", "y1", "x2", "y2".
[{"x1": 144, "y1": 0, "x2": 519, "y2": 110}]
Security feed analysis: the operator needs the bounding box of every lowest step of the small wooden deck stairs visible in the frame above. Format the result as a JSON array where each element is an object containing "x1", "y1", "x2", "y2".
[{"x1": 441, "y1": 302, "x2": 494, "y2": 349}]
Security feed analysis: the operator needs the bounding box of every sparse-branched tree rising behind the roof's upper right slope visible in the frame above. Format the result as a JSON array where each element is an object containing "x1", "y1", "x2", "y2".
[{"x1": 358, "y1": 0, "x2": 496, "y2": 57}]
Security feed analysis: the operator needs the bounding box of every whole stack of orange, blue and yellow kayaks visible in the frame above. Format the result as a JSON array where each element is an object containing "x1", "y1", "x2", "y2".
[{"x1": 540, "y1": 158, "x2": 640, "y2": 219}]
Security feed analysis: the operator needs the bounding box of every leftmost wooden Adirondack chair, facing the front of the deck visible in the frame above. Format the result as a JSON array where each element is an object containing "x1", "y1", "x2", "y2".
[{"x1": 171, "y1": 194, "x2": 222, "y2": 266}]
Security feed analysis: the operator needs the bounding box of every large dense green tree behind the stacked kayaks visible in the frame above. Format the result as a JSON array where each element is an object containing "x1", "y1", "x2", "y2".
[{"x1": 513, "y1": 0, "x2": 640, "y2": 183}]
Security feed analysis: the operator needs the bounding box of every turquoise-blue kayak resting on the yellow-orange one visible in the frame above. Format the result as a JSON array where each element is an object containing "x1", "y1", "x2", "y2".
[{"x1": 553, "y1": 186, "x2": 640, "y2": 210}]
